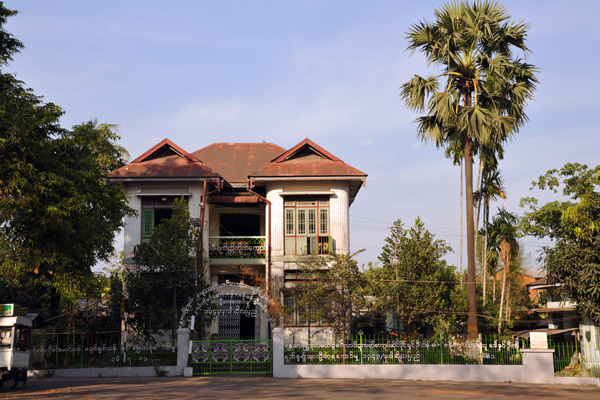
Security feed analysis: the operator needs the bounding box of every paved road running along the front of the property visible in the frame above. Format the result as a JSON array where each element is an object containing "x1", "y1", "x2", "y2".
[{"x1": 0, "y1": 376, "x2": 600, "y2": 400}]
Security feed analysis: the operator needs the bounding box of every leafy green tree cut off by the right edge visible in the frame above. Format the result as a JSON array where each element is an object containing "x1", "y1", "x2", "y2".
[{"x1": 521, "y1": 163, "x2": 600, "y2": 323}]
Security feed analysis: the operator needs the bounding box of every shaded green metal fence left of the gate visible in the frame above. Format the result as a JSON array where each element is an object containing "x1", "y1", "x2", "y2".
[{"x1": 29, "y1": 334, "x2": 177, "y2": 369}]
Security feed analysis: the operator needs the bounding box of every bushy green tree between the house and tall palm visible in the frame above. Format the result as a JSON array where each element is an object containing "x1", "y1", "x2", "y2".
[{"x1": 368, "y1": 218, "x2": 461, "y2": 333}]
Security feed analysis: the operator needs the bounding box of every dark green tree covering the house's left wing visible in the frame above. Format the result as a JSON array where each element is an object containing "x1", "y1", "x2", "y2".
[{"x1": 125, "y1": 198, "x2": 204, "y2": 340}]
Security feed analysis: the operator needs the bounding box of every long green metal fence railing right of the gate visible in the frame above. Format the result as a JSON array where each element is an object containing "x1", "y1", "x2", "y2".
[{"x1": 284, "y1": 336, "x2": 527, "y2": 365}]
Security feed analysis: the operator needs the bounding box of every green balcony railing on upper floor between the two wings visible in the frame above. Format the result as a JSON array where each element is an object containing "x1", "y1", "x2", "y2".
[{"x1": 208, "y1": 236, "x2": 267, "y2": 258}]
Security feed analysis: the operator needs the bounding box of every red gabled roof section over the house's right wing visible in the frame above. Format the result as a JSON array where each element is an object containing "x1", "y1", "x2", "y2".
[{"x1": 252, "y1": 139, "x2": 367, "y2": 178}]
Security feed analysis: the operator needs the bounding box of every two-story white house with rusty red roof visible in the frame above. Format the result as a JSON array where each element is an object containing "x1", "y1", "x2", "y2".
[{"x1": 111, "y1": 139, "x2": 367, "y2": 338}]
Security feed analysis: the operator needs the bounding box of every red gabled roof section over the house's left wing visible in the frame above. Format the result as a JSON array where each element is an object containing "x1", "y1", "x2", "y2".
[{"x1": 110, "y1": 139, "x2": 220, "y2": 181}]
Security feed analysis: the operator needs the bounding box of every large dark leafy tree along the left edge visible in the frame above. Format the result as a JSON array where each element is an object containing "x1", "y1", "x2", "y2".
[{"x1": 0, "y1": 4, "x2": 132, "y2": 315}]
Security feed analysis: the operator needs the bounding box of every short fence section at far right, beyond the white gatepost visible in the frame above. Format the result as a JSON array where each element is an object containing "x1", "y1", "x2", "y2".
[{"x1": 548, "y1": 341, "x2": 600, "y2": 377}]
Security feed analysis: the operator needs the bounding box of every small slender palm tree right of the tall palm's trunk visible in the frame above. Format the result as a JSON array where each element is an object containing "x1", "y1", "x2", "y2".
[{"x1": 490, "y1": 207, "x2": 519, "y2": 334}]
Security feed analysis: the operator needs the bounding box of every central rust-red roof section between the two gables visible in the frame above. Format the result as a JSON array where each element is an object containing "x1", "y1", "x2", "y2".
[{"x1": 192, "y1": 143, "x2": 285, "y2": 183}]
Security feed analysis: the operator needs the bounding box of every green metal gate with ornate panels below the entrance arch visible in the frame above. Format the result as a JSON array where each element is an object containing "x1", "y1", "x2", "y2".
[{"x1": 192, "y1": 339, "x2": 273, "y2": 375}]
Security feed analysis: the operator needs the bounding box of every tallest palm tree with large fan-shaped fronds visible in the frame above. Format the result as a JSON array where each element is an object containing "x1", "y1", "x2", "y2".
[{"x1": 401, "y1": 1, "x2": 537, "y2": 338}]
